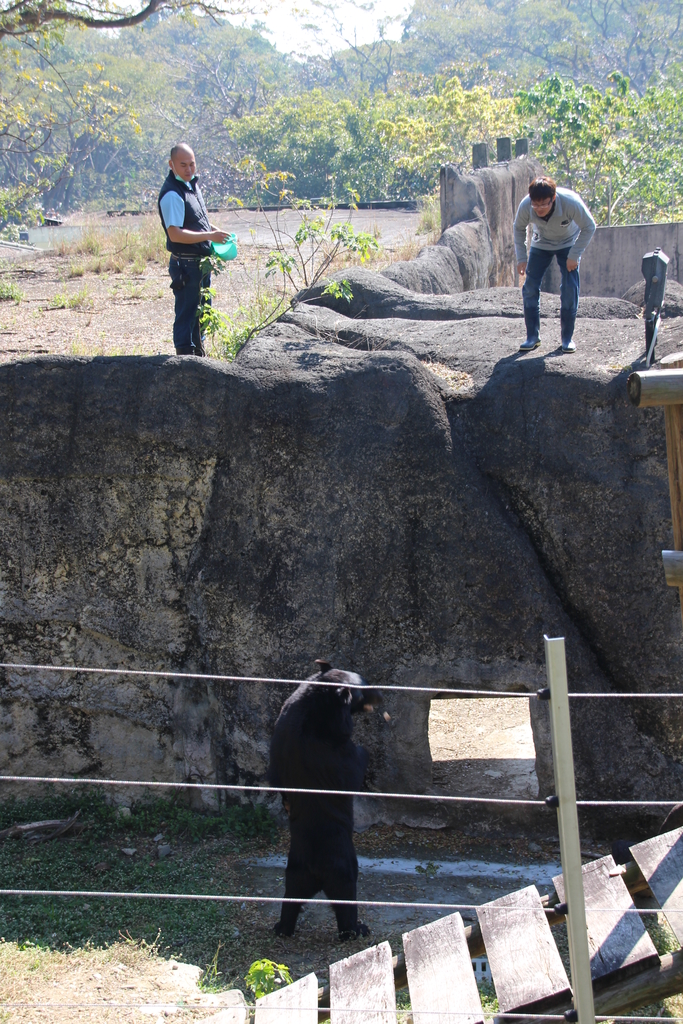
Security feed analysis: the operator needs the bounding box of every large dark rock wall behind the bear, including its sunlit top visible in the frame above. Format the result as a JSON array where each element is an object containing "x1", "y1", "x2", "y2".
[{"x1": 0, "y1": 301, "x2": 683, "y2": 822}]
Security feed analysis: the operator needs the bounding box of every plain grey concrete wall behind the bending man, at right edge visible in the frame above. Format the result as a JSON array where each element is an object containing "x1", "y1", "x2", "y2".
[{"x1": 543, "y1": 224, "x2": 683, "y2": 297}]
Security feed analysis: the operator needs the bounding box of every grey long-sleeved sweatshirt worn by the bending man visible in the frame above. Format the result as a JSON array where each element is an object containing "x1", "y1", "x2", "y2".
[{"x1": 514, "y1": 188, "x2": 595, "y2": 263}]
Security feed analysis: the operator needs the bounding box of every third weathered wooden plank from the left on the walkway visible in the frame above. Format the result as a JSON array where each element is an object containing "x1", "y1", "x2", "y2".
[{"x1": 403, "y1": 913, "x2": 483, "y2": 1024}]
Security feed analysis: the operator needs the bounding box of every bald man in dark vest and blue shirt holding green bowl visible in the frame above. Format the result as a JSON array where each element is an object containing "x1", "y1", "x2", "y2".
[{"x1": 159, "y1": 142, "x2": 227, "y2": 355}]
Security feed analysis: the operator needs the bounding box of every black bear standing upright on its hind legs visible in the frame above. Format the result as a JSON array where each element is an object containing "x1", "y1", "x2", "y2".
[{"x1": 268, "y1": 660, "x2": 382, "y2": 938}]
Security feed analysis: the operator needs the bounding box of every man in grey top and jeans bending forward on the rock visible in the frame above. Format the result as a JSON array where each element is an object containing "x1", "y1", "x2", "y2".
[{"x1": 514, "y1": 176, "x2": 595, "y2": 352}]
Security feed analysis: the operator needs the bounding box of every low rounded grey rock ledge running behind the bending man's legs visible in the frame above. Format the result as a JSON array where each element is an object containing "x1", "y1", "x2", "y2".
[{"x1": 297, "y1": 274, "x2": 639, "y2": 321}]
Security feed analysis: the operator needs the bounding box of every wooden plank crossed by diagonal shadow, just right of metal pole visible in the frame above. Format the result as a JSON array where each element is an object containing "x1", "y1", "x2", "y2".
[{"x1": 553, "y1": 856, "x2": 659, "y2": 981}]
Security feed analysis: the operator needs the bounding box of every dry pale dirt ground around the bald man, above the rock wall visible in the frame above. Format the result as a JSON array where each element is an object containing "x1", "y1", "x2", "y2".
[{"x1": 0, "y1": 211, "x2": 430, "y2": 362}]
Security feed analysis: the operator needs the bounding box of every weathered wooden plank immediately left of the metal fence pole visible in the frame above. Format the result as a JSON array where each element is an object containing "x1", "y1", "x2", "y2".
[{"x1": 477, "y1": 886, "x2": 571, "y2": 1013}]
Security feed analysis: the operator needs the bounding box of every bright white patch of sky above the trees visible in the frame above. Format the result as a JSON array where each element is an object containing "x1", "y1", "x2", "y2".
[{"x1": 232, "y1": 0, "x2": 411, "y2": 56}]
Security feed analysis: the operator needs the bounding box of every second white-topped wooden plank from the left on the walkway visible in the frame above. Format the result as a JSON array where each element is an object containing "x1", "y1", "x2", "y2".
[{"x1": 330, "y1": 942, "x2": 396, "y2": 1024}]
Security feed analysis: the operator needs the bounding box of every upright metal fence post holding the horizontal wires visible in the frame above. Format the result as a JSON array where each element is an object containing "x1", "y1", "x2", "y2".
[{"x1": 544, "y1": 637, "x2": 595, "y2": 1024}]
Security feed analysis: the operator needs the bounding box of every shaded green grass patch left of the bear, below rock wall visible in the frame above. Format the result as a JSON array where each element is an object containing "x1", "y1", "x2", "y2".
[{"x1": 0, "y1": 793, "x2": 279, "y2": 966}]
